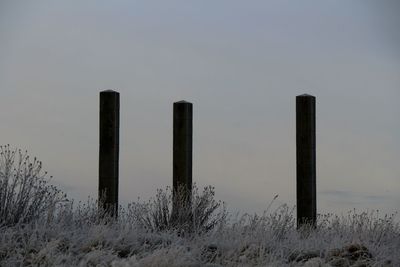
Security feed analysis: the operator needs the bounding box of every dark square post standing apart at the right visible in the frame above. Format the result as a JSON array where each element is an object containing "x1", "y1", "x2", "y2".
[{"x1": 296, "y1": 94, "x2": 317, "y2": 228}]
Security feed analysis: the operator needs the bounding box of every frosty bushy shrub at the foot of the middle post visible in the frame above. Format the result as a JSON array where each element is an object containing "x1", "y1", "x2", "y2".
[{"x1": 127, "y1": 185, "x2": 227, "y2": 236}]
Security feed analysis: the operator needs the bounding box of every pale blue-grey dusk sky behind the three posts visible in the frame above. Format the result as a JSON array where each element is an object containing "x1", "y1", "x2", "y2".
[{"x1": 0, "y1": 0, "x2": 400, "y2": 219}]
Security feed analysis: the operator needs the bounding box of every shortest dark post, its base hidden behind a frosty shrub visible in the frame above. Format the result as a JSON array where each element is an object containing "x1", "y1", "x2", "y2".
[{"x1": 172, "y1": 101, "x2": 193, "y2": 210}]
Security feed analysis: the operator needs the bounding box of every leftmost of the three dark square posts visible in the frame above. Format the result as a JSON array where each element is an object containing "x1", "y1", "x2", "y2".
[{"x1": 99, "y1": 90, "x2": 119, "y2": 217}]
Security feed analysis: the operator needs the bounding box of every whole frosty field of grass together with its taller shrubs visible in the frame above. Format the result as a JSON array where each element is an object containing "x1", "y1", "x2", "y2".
[{"x1": 0, "y1": 146, "x2": 400, "y2": 267}]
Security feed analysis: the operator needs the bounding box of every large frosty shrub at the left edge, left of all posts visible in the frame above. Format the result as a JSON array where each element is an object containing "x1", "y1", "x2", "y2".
[{"x1": 0, "y1": 145, "x2": 66, "y2": 226}]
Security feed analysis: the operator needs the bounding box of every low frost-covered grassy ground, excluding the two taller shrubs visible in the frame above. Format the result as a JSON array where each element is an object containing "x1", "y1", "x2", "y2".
[{"x1": 0, "y1": 203, "x2": 400, "y2": 267}]
